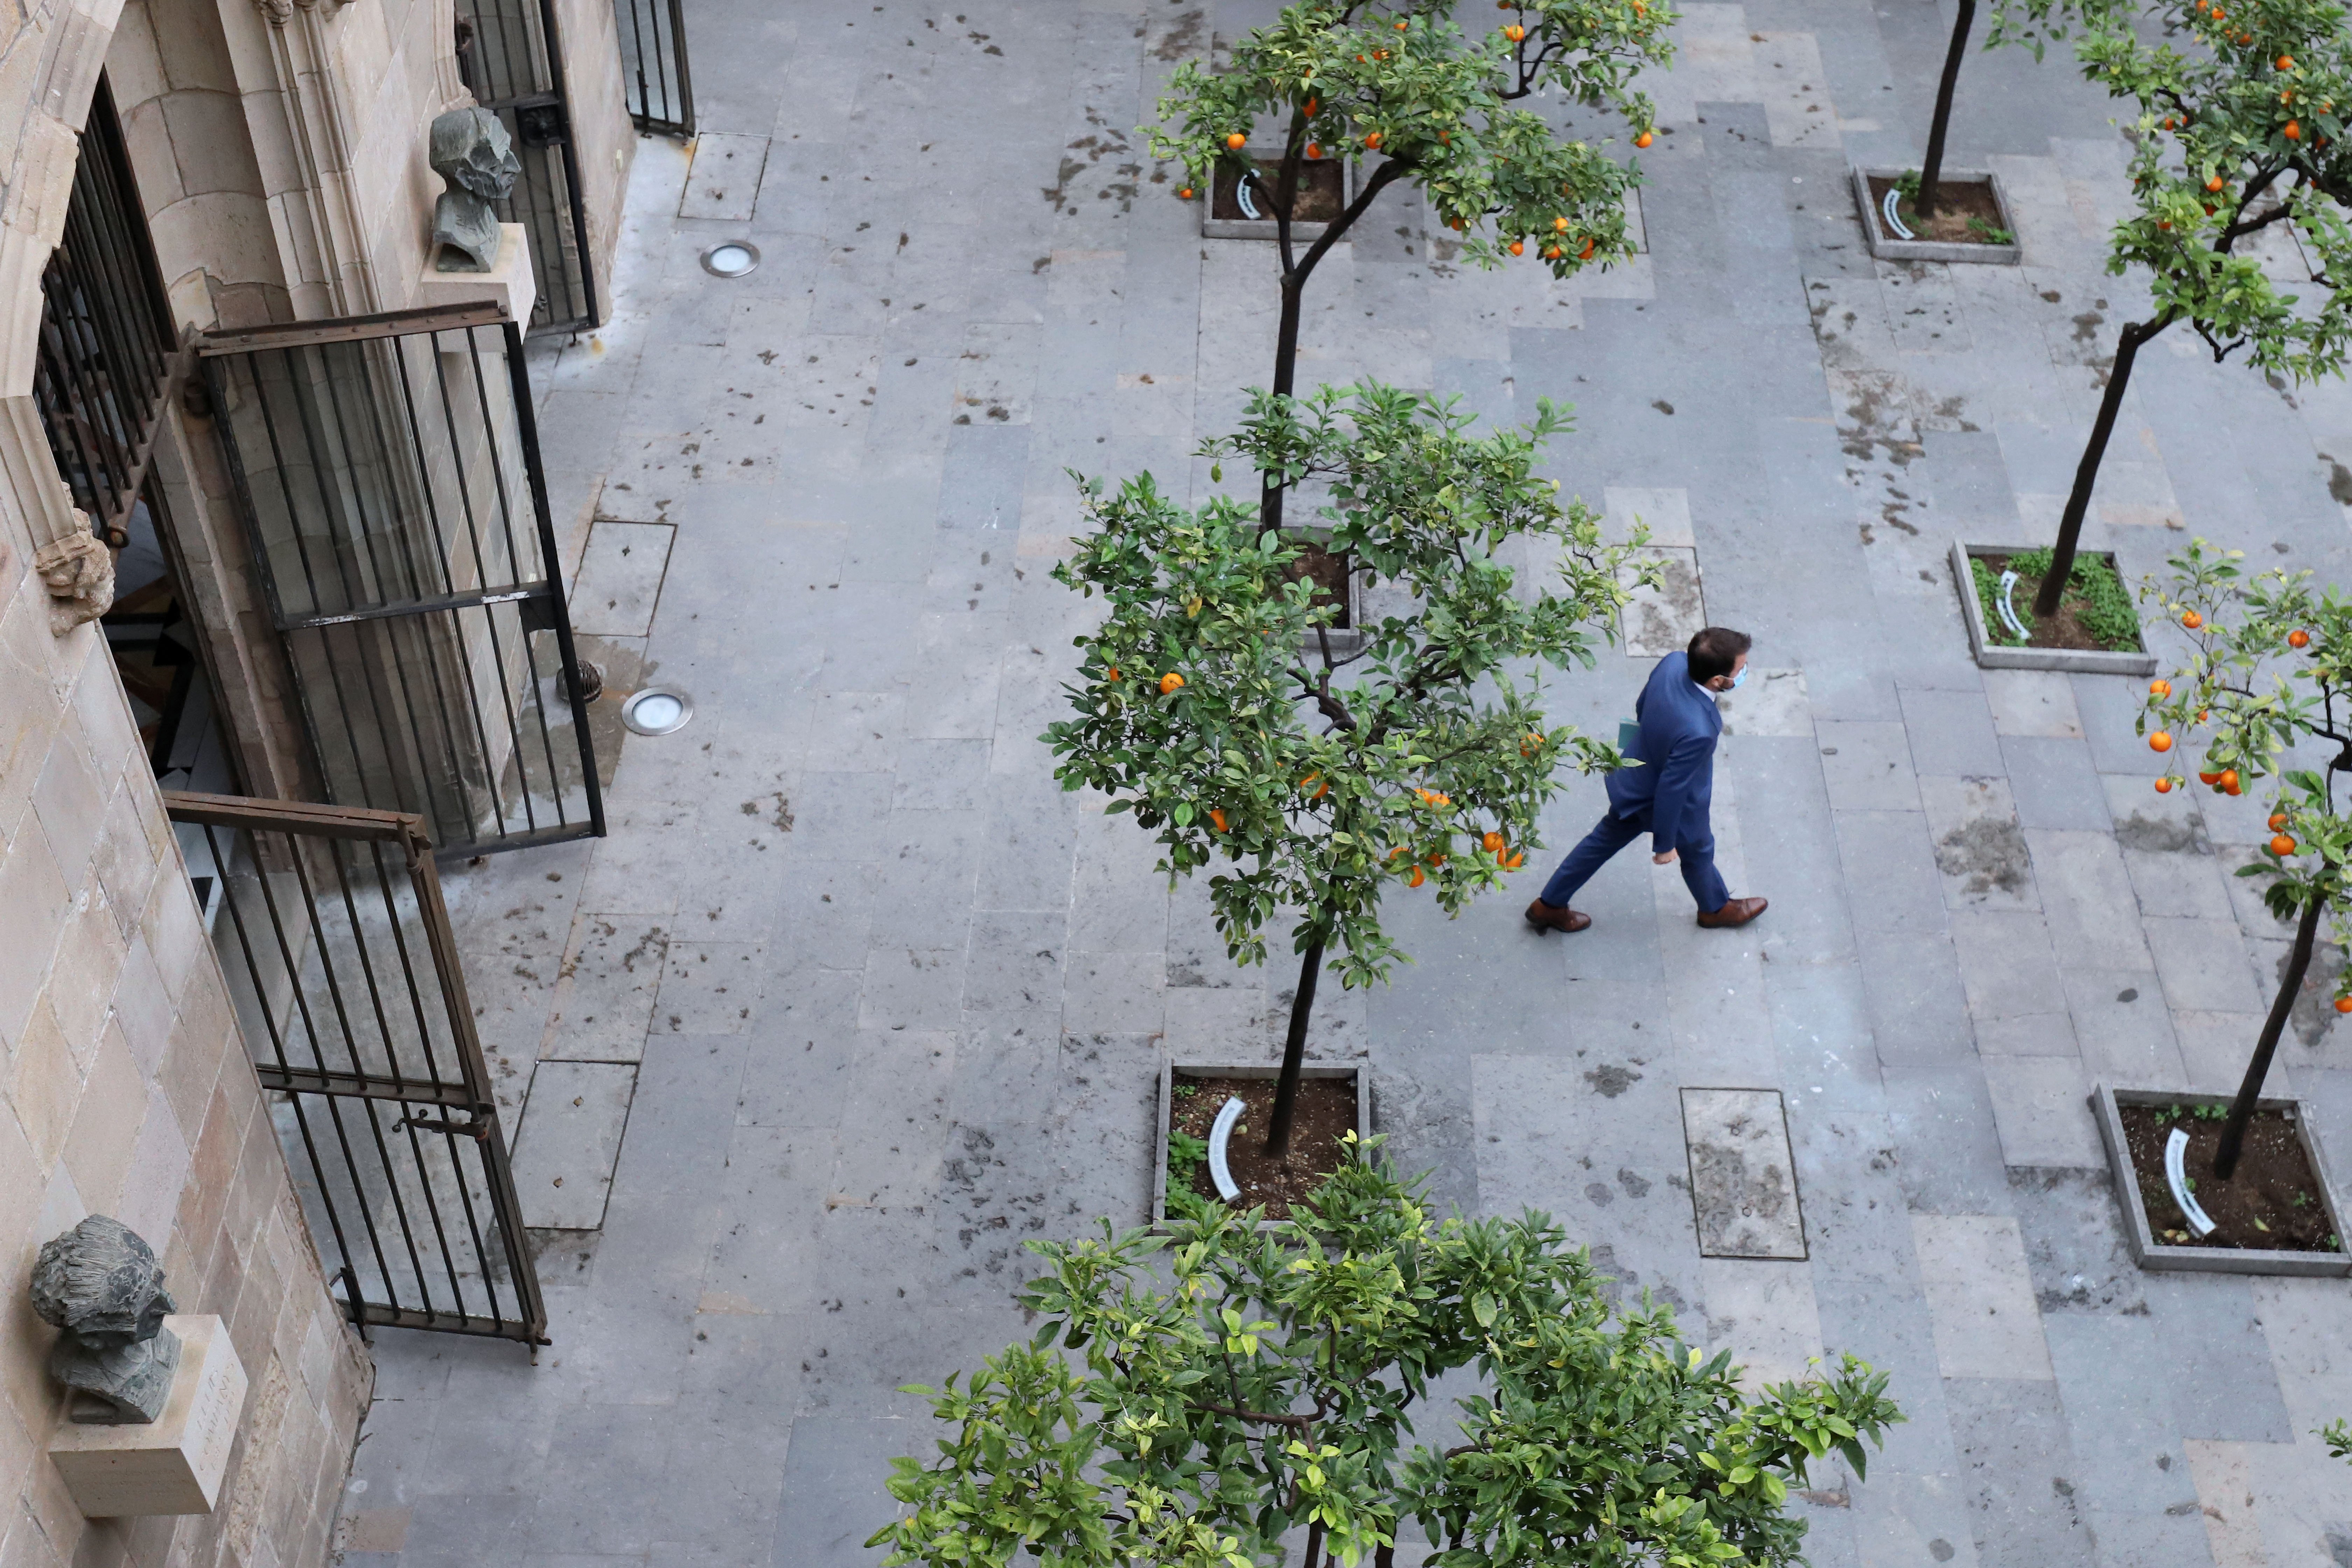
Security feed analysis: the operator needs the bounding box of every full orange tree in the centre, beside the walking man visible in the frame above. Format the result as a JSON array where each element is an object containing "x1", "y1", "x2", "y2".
[{"x1": 1044, "y1": 381, "x2": 1632, "y2": 1154}]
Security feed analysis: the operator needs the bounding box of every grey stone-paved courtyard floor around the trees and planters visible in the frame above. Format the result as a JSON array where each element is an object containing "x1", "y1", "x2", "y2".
[{"x1": 343, "y1": 0, "x2": 2352, "y2": 1568}]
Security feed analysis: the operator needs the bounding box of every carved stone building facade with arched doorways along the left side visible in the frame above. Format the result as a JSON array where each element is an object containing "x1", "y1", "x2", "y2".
[{"x1": 0, "y1": 0, "x2": 635, "y2": 1568}]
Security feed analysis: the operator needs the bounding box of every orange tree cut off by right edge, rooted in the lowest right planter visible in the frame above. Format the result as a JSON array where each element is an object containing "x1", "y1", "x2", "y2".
[{"x1": 2140, "y1": 538, "x2": 2352, "y2": 1180}]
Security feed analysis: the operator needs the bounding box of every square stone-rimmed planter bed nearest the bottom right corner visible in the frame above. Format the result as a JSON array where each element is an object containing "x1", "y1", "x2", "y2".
[{"x1": 2091, "y1": 1084, "x2": 2352, "y2": 1279}]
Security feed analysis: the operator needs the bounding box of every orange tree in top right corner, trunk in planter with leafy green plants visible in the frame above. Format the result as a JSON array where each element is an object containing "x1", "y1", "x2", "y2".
[{"x1": 1997, "y1": 0, "x2": 2352, "y2": 618}]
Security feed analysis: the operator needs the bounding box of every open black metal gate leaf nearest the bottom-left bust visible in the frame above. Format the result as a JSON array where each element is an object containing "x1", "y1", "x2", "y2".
[{"x1": 164, "y1": 792, "x2": 548, "y2": 1345}]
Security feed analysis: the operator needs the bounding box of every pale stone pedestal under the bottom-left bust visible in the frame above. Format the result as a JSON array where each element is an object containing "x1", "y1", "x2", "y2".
[{"x1": 49, "y1": 1314, "x2": 245, "y2": 1519}]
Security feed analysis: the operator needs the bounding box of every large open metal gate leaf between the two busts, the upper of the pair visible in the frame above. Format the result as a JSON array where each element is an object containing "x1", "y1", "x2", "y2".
[{"x1": 197, "y1": 306, "x2": 604, "y2": 856}]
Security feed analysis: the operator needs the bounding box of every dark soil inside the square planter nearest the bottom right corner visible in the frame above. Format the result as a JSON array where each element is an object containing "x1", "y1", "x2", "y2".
[{"x1": 2117, "y1": 1105, "x2": 2340, "y2": 1253}]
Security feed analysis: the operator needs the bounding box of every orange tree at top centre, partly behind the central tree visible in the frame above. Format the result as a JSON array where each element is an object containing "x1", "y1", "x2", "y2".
[{"x1": 1141, "y1": 0, "x2": 1677, "y2": 527}]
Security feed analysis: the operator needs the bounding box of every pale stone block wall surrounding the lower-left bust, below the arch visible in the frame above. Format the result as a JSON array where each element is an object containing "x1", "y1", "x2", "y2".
[{"x1": 0, "y1": 533, "x2": 372, "y2": 1568}]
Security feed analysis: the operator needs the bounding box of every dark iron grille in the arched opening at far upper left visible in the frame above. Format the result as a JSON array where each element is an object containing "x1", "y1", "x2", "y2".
[{"x1": 33, "y1": 73, "x2": 186, "y2": 545}]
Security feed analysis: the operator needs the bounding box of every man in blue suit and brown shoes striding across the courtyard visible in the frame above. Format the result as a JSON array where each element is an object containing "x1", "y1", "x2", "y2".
[{"x1": 1526, "y1": 625, "x2": 1764, "y2": 931}]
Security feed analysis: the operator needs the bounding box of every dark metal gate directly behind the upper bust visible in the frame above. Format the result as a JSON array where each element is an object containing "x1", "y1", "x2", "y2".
[{"x1": 456, "y1": 0, "x2": 602, "y2": 331}]
